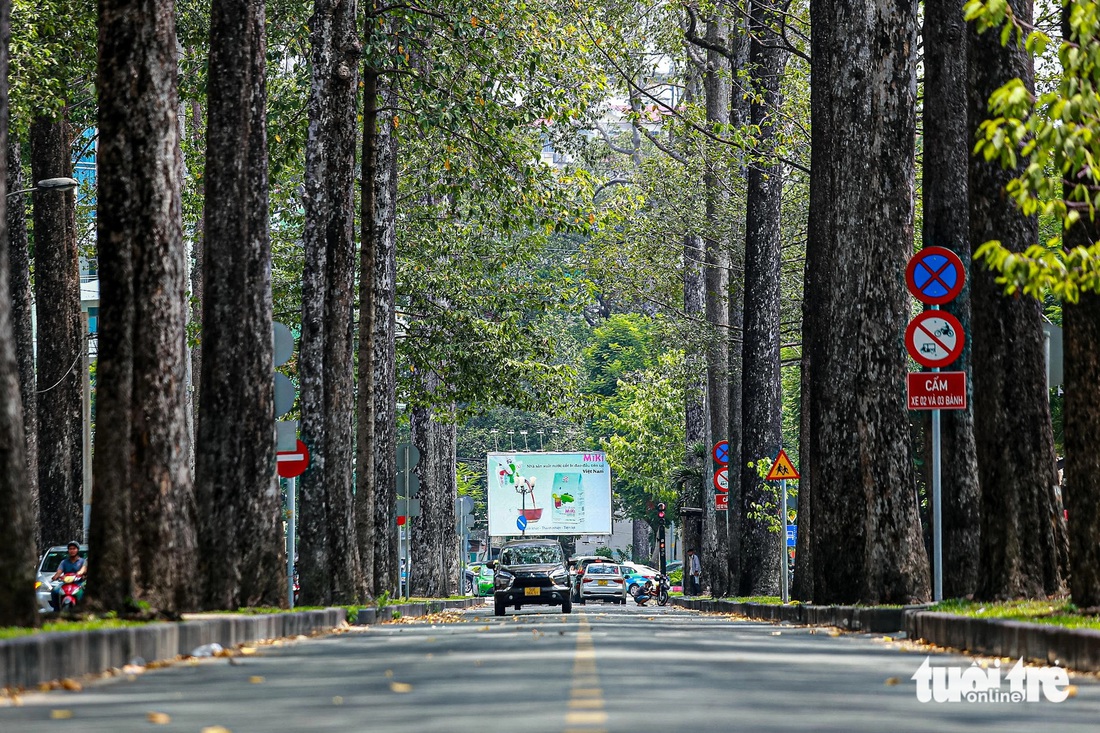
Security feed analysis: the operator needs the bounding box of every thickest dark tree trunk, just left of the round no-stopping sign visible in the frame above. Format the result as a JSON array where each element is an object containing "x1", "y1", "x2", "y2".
[{"x1": 803, "y1": 0, "x2": 930, "y2": 603}]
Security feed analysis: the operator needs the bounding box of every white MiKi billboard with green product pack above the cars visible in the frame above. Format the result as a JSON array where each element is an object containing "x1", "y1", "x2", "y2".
[{"x1": 486, "y1": 451, "x2": 612, "y2": 536}]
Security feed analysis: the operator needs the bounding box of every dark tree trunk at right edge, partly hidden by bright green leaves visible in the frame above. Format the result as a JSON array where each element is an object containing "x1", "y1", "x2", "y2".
[{"x1": 1062, "y1": 4, "x2": 1100, "y2": 610}]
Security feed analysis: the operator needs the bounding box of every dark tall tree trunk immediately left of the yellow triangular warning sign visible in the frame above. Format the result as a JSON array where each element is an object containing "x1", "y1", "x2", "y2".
[{"x1": 730, "y1": 4, "x2": 788, "y2": 595}]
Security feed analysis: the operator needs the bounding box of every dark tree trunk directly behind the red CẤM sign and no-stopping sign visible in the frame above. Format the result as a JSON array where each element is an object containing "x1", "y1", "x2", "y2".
[{"x1": 922, "y1": 0, "x2": 981, "y2": 598}]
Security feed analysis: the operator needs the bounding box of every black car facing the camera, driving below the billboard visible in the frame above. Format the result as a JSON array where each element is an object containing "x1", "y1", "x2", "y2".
[{"x1": 493, "y1": 539, "x2": 573, "y2": 616}]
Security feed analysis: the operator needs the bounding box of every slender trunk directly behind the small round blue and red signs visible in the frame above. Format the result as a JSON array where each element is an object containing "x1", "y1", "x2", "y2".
[{"x1": 701, "y1": 20, "x2": 729, "y2": 597}]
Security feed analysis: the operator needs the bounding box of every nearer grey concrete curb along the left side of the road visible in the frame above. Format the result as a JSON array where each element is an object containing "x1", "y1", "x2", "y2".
[{"x1": 0, "y1": 609, "x2": 347, "y2": 688}]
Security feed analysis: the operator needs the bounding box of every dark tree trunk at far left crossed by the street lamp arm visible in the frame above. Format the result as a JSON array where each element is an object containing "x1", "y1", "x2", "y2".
[{"x1": 31, "y1": 118, "x2": 84, "y2": 547}]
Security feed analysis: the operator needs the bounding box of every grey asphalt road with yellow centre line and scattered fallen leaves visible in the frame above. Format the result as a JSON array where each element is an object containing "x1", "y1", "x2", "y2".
[{"x1": 0, "y1": 601, "x2": 1100, "y2": 733}]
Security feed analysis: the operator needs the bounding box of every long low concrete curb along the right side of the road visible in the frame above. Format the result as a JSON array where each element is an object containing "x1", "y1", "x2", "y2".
[{"x1": 672, "y1": 598, "x2": 1100, "y2": 671}]
